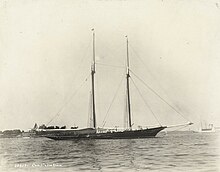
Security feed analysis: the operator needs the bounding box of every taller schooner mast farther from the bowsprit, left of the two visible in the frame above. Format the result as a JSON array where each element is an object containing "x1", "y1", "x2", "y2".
[{"x1": 91, "y1": 29, "x2": 96, "y2": 128}]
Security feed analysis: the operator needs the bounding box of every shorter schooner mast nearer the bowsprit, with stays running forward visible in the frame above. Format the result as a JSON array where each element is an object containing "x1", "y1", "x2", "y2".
[{"x1": 126, "y1": 36, "x2": 132, "y2": 130}]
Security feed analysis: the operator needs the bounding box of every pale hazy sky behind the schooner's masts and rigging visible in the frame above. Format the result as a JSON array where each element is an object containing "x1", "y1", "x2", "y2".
[{"x1": 0, "y1": 0, "x2": 220, "y2": 130}]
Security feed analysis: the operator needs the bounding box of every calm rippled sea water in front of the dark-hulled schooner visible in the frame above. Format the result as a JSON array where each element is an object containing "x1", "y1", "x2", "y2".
[{"x1": 0, "y1": 132, "x2": 220, "y2": 172}]
